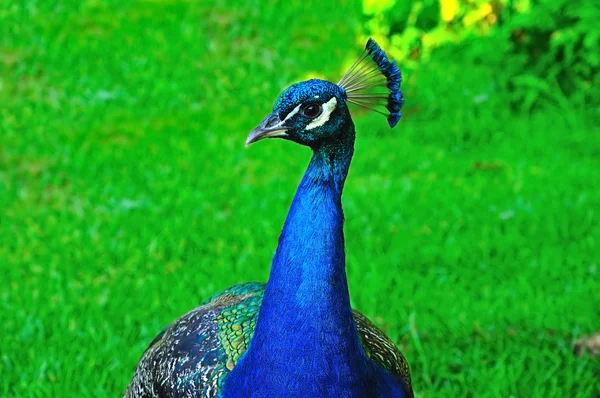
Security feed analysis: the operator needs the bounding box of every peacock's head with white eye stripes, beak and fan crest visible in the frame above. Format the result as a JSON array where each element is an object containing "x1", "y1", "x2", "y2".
[{"x1": 246, "y1": 39, "x2": 404, "y2": 149}]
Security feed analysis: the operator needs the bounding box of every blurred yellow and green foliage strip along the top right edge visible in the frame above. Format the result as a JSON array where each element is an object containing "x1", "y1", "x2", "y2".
[{"x1": 366, "y1": 0, "x2": 600, "y2": 110}]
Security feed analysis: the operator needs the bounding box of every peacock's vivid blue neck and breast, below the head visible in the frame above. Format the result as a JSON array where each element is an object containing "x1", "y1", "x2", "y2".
[{"x1": 222, "y1": 126, "x2": 390, "y2": 397}]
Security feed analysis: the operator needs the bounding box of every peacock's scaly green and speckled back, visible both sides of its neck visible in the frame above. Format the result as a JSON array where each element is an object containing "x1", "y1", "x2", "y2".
[{"x1": 125, "y1": 283, "x2": 411, "y2": 398}]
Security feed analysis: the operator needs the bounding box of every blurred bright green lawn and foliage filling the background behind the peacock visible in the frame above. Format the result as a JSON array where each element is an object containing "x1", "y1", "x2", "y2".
[{"x1": 0, "y1": 0, "x2": 600, "y2": 398}]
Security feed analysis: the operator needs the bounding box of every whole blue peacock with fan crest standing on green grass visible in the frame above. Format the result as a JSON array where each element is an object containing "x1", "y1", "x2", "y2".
[{"x1": 125, "y1": 39, "x2": 413, "y2": 398}]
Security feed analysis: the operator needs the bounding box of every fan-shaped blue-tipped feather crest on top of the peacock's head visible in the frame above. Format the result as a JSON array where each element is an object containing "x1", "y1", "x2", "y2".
[{"x1": 338, "y1": 39, "x2": 404, "y2": 127}]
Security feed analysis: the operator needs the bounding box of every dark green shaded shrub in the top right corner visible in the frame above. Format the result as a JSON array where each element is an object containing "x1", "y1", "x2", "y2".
[{"x1": 503, "y1": 0, "x2": 600, "y2": 109}]
